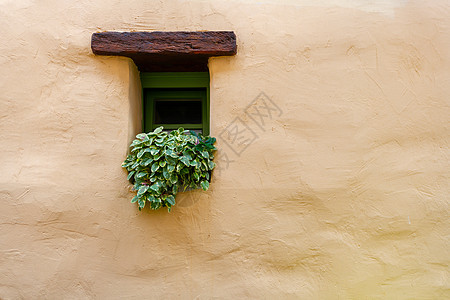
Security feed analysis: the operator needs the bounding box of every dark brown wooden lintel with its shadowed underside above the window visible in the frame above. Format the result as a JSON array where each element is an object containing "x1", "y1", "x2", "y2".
[{"x1": 91, "y1": 31, "x2": 236, "y2": 72}]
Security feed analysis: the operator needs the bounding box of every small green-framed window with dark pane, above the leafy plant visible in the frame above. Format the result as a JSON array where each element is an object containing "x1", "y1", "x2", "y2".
[{"x1": 141, "y1": 72, "x2": 209, "y2": 135}]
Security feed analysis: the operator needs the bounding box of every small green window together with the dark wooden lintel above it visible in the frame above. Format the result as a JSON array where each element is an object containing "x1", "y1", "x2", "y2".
[{"x1": 91, "y1": 31, "x2": 237, "y2": 135}]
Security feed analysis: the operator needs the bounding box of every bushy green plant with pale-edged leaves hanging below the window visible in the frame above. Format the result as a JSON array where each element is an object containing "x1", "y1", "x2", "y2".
[{"x1": 122, "y1": 127, "x2": 216, "y2": 211}]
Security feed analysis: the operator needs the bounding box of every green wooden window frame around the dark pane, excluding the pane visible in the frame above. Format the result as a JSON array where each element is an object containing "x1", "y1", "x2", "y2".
[{"x1": 140, "y1": 72, "x2": 210, "y2": 135}]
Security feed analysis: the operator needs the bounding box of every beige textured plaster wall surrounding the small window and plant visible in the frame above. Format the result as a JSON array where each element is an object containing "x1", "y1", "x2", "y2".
[{"x1": 0, "y1": 0, "x2": 450, "y2": 299}]
